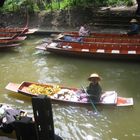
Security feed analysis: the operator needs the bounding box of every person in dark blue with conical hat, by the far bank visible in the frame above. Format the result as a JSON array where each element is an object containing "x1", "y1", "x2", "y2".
[{"x1": 127, "y1": 19, "x2": 140, "y2": 35}]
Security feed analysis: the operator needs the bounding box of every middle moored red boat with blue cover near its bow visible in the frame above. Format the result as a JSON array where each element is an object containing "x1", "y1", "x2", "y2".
[{"x1": 53, "y1": 34, "x2": 140, "y2": 45}]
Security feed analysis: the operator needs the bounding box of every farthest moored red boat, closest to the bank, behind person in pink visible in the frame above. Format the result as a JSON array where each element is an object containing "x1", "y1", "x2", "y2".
[{"x1": 62, "y1": 31, "x2": 140, "y2": 38}]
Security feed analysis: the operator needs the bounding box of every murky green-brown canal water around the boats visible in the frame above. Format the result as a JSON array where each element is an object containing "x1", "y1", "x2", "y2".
[{"x1": 0, "y1": 36, "x2": 140, "y2": 140}]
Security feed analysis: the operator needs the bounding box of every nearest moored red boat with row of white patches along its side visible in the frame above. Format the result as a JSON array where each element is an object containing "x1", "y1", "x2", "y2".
[{"x1": 36, "y1": 42, "x2": 140, "y2": 60}]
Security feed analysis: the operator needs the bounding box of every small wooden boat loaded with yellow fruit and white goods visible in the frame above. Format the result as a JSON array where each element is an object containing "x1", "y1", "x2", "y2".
[{"x1": 5, "y1": 81, "x2": 133, "y2": 106}]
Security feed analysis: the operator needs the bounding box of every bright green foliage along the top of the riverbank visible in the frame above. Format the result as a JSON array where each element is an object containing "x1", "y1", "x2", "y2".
[{"x1": 0, "y1": 0, "x2": 133, "y2": 12}]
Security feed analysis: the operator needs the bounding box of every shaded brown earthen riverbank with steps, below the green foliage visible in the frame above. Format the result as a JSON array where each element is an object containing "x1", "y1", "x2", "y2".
[{"x1": 0, "y1": 5, "x2": 137, "y2": 31}]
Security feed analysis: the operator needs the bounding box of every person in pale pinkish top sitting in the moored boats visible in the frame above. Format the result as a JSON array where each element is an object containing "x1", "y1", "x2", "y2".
[{"x1": 79, "y1": 24, "x2": 90, "y2": 36}]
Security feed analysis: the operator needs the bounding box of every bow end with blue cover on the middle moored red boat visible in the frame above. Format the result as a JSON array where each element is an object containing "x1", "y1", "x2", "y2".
[{"x1": 57, "y1": 34, "x2": 82, "y2": 42}]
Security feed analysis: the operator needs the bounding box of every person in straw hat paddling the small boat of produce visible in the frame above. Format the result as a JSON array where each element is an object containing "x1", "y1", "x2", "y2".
[{"x1": 87, "y1": 73, "x2": 102, "y2": 102}]
